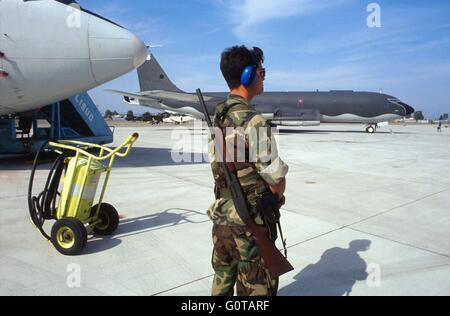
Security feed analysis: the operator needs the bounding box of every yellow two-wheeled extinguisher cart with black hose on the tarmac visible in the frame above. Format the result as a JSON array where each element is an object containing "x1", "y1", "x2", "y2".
[{"x1": 28, "y1": 133, "x2": 139, "y2": 256}]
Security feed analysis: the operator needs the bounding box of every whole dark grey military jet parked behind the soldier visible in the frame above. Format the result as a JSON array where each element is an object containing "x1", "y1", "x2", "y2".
[{"x1": 108, "y1": 55, "x2": 414, "y2": 133}]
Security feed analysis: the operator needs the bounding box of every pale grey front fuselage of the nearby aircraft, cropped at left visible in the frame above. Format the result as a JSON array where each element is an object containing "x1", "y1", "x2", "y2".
[{"x1": 0, "y1": 0, "x2": 148, "y2": 116}]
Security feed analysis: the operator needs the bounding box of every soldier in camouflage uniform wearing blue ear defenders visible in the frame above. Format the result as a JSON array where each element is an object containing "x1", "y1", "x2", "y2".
[{"x1": 208, "y1": 46, "x2": 288, "y2": 296}]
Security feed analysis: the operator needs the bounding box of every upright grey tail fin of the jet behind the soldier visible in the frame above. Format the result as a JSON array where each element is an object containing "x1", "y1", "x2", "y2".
[{"x1": 137, "y1": 54, "x2": 183, "y2": 93}]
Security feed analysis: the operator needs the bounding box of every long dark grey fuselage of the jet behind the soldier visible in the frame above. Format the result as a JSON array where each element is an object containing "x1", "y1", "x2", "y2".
[{"x1": 153, "y1": 91, "x2": 414, "y2": 124}]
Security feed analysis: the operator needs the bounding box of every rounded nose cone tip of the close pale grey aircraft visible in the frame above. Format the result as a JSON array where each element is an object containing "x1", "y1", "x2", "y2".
[{"x1": 88, "y1": 16, "x2": 148, "y2": 85}]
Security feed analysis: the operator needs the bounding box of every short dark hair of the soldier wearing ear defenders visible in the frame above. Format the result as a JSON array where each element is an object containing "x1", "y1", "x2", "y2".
[{"x1": 220, "y1": 45, "x2": 264, "y2": 89}]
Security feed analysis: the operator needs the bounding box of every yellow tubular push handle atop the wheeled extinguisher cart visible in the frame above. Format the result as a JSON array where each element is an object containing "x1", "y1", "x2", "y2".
[{"x1": 49, "y1": 133, "x2": 139, "y2": 161}]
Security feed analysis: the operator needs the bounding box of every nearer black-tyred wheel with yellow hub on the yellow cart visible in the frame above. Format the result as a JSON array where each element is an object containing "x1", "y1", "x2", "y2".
[{"x1": 51, "y1": 218, "x2": 87, "y2": 256}]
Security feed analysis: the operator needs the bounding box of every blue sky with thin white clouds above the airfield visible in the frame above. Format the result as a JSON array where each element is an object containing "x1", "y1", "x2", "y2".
[{"x1": 79, "y1": 0, "x2": 450, "y2": 118}]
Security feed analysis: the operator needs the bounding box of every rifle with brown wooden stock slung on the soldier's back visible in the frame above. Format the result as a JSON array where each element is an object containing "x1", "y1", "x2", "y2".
[{"x1": 197, "y1": 89, "x2": 294, "y2": 278}]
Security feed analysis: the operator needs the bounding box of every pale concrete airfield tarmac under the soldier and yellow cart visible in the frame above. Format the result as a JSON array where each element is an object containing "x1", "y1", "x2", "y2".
[{"x1": 0, "y1": 124, "x2": 450, "y2": 296}]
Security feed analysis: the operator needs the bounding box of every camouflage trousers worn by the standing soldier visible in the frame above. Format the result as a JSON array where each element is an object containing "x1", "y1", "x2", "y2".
[{"x1": 212, "y1": 225, "x2": 278, "y2": 296}]
